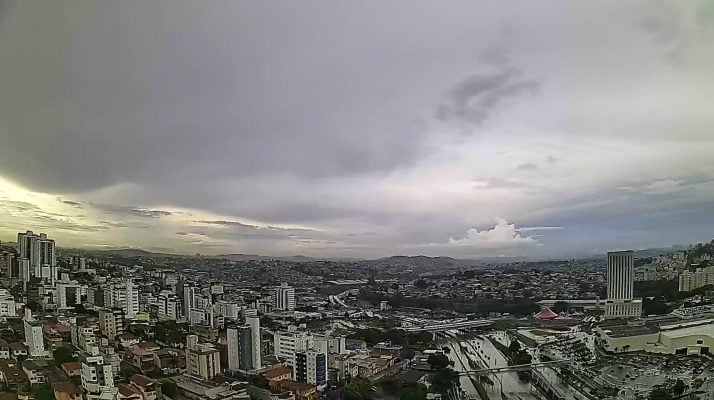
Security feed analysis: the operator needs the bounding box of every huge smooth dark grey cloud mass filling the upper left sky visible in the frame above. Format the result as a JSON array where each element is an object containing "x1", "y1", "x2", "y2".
[{"x1": 0, "y1": 1, "x2": 440, "y2": 191}]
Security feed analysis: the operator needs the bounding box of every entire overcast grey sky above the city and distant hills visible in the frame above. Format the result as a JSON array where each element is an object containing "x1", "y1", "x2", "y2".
[{"x1": 0, "y1": 0, "x2": 714, "y2": 258}]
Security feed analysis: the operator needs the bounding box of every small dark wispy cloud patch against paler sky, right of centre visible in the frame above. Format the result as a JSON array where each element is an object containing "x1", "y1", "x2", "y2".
[{"x1": 437, "y1": 67, "x2": 539, "y2": 125}]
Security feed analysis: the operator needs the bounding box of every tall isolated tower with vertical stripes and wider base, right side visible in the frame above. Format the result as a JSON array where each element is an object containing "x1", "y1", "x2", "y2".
[{"x1": 605, "y1": 250, "x2": 642, "y2": 318}]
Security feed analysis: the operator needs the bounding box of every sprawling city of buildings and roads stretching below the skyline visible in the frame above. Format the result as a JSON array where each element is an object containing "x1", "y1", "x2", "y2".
[{"x1": 0, "y1": 231, "x2": 714, "y2": 400}]
